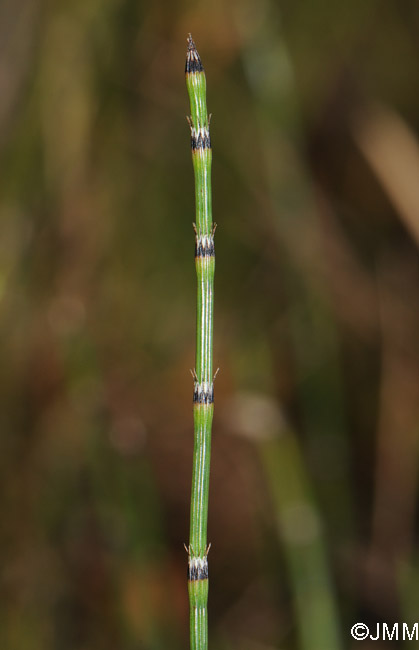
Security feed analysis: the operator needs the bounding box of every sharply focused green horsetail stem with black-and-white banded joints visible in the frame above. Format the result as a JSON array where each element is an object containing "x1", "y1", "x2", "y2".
[{"x1": 185, "y1": 34, "x2": 215, "y2": 650}]
